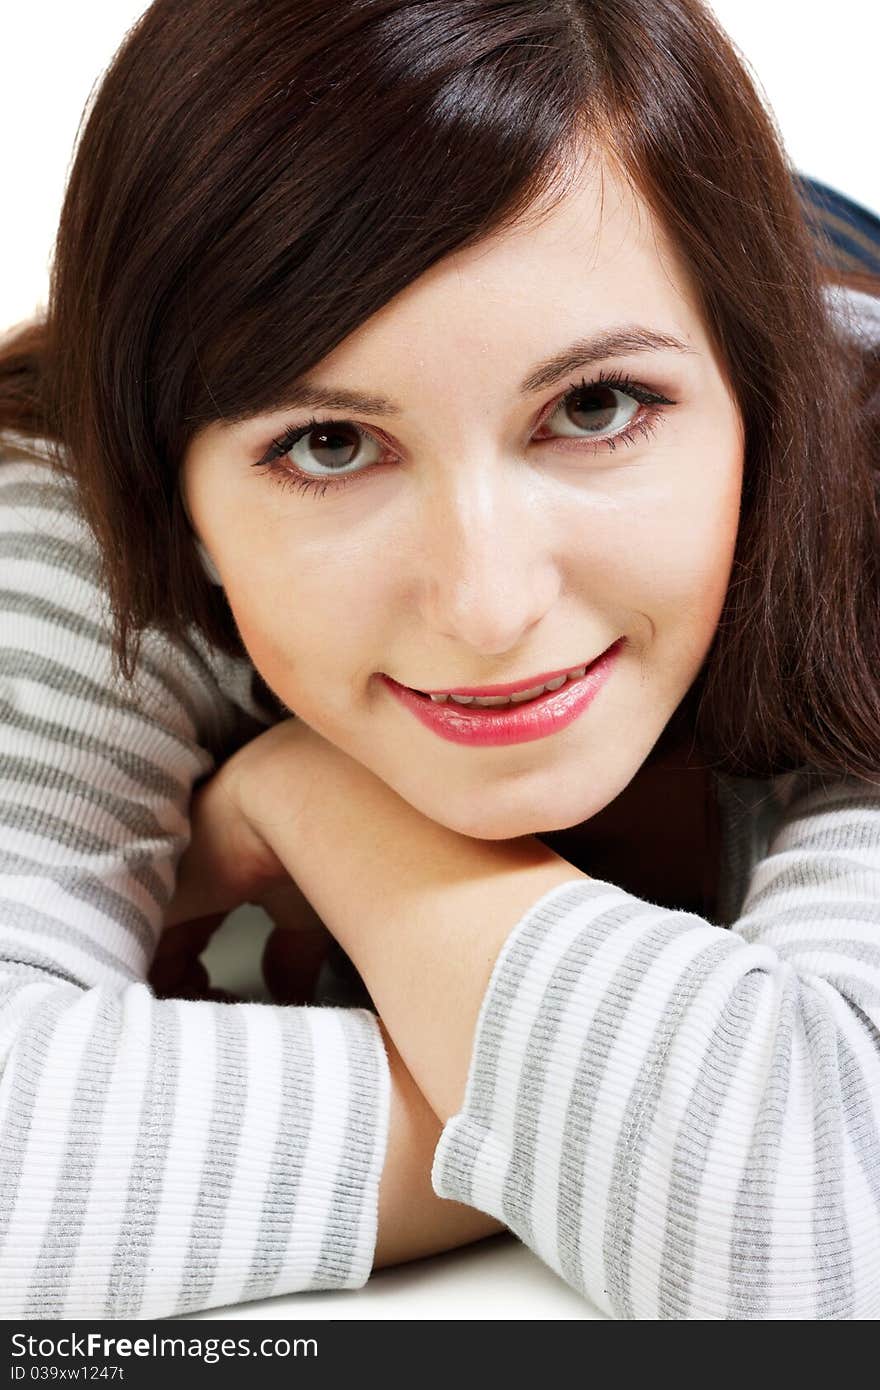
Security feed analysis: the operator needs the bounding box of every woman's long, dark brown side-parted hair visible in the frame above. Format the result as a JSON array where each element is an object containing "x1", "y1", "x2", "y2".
[{"x1": 0, "y1": 0, "x2": 880, "y2": 778}]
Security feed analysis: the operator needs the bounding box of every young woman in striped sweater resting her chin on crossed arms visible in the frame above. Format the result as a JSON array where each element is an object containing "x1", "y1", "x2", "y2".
[{"x1": 0, "y1": 0, "x2": 880, "y2": 1318}]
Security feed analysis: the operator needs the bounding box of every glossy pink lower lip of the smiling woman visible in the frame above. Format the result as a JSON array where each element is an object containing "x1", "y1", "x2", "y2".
[{"x1": 382, "y1": 637, "x2": 626, "y2": 748}]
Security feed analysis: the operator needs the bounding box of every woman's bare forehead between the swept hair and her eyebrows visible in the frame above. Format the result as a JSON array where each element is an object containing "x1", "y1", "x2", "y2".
[{"x1": 310, "y1": 164, "x2": 699, "y2": 381}]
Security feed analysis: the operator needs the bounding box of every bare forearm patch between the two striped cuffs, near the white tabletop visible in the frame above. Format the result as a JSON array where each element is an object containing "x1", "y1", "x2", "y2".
[{"x1": 374, "y1": 1020, "x2": 505, "y2": 1269}]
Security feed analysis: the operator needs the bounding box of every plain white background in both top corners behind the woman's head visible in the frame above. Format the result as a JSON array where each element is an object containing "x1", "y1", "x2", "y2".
[{"x1": 0, "y1": 0, "x2": 880, "y2": 332}]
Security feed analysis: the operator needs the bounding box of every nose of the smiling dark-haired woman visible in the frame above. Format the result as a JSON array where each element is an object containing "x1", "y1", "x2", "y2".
[{"x1": 417, "y1": 457, "x2": 560, "y2": 656}]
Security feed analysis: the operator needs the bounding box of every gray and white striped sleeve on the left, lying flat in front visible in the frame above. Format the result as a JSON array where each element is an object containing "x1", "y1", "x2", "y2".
[{"x1": 0, "y1": 457, "x2": 389, "y2": 1319}]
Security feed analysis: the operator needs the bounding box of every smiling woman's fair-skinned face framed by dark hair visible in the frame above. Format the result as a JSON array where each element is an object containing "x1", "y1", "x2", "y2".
[{"x1": 182, "y1": 157, "x2": 742, "y2": 840}]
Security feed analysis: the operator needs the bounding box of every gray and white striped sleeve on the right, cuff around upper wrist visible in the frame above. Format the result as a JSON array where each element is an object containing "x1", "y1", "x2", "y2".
[{"x1": 432, "y1": 774, "x2": 880, "y2": 1321}]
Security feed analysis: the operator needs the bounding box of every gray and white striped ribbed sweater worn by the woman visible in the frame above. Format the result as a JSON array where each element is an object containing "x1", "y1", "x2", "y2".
[{"x1": 0, "y1": 282, "x2": 880, "y2": 1319}]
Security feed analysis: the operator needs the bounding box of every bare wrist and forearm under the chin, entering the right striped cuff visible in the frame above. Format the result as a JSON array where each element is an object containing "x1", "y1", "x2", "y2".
[{"x1": 250, "y1": 744, "x2": 587, "y2": 1123}]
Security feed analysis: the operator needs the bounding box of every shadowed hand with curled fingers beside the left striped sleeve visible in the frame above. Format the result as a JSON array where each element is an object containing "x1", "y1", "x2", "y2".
[{"x1": 147, "y1": 720, "x2": 331, "y2": 1004}]
